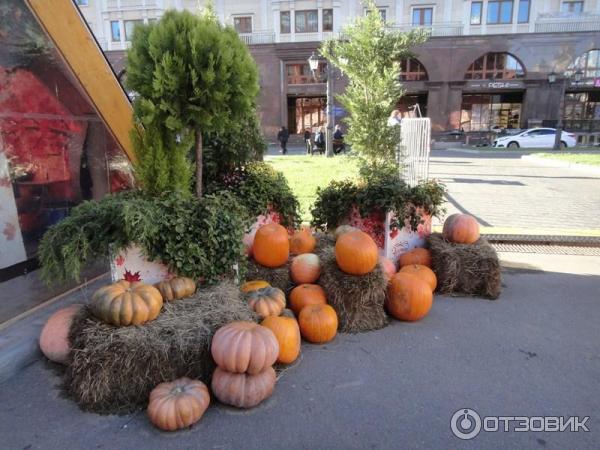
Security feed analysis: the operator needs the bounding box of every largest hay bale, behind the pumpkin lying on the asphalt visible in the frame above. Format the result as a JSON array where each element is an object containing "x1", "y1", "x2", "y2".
[{"x1": 64, "y1": 282, "x2": 256, "y2": 414}]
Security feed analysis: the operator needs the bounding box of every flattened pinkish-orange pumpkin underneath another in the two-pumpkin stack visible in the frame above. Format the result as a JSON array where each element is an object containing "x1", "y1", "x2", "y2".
[{"x1": 211, "y1": 367, "x2": 276, "y2": 408}]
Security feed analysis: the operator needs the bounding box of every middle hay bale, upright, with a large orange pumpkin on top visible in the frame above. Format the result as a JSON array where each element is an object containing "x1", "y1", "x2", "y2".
[{"x1": 319, "y1": 246, "x2": 388, "y2": 333}]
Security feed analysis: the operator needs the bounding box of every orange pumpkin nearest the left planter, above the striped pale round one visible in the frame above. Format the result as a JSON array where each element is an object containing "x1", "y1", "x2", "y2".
[{"x1": 252, "y1": 223, "x2": 290, "y2": 268}]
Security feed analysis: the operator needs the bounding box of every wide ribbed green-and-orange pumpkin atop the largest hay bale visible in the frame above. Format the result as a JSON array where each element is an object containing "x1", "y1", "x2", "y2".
[{"x1": 90, "y1": 280, "x2": 163, "y2": 327}]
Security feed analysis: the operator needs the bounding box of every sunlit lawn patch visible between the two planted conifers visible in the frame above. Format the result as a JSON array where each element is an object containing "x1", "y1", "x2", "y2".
[{"x1": 265, "y1": 155, "x2": 358, "y2": 222}]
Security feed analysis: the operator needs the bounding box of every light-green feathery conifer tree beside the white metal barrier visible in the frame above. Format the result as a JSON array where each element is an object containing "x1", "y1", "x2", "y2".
[{"x1": 320, "y1": 0, "x2": 427, "y2": 166}]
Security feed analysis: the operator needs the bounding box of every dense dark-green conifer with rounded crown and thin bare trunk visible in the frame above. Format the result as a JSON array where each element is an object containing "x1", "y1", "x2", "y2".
[{"x1": 127, "y1": 8, "x2": 259, "y2": 197}]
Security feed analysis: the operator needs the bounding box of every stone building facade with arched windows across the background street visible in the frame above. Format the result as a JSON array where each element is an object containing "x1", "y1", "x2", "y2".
[{"x1": 78, "y1": 0, "x2": 600, "y2": 142}]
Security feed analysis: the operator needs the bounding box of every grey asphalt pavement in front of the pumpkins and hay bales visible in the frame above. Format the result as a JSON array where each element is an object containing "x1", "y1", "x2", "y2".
[{"x1": 0, "y1": 271, "x2": 600, "y2": 450}]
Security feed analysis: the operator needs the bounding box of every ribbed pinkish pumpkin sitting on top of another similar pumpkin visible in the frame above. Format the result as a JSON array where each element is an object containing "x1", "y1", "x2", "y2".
[{"x1": 210, "y1": 321, "x2": 279, "y2": 374}]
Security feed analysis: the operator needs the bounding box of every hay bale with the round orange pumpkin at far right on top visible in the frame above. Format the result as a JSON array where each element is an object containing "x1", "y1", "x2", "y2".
[{"x1": 428, "y1": 233, "x2": 502, "y2": 300}]
